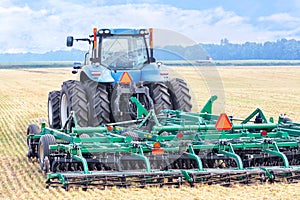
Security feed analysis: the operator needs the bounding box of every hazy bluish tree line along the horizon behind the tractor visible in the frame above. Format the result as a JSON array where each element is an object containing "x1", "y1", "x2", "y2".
[{"x1": 0, "y1": 38, "x2": 300, "y2": 62}]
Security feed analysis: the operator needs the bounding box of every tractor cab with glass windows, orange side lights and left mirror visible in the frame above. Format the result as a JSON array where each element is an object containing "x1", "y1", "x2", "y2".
[{"x1": 67, "y1": 28, "x2": 155, "y2": 70}]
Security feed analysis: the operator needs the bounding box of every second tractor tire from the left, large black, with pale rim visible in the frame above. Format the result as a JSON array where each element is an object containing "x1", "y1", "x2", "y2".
[{"x1": 60, "y1": 80, "x2": 88, "y2": 127}]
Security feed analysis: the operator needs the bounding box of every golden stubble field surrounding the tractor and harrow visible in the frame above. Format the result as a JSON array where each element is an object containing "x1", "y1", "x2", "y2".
[{"x1": 0, "y1": 66, "x2": 300, "y2": 199}]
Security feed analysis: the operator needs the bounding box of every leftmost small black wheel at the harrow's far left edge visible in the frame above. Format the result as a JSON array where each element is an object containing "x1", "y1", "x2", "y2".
[{"x1": 26, "y1": 124, "x2": 41, "y2": 158}]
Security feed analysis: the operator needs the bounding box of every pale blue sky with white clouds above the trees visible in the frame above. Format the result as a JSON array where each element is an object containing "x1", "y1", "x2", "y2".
[{"x1": 0, "y1": 0, "x2": 300, "y2": 53}]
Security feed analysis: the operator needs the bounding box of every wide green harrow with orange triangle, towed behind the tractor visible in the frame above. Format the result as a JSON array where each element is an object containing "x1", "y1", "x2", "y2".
[{"x1": 27, "y1": 96, "x2": 300, "y2": 189}]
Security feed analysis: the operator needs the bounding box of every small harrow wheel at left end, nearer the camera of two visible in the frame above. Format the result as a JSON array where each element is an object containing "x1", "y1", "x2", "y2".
[{"x1": 38, "y1": 134, "x2": 56, "y2": 173}]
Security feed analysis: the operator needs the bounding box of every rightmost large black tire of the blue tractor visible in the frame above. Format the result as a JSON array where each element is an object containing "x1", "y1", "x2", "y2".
[{"x1": 168, "y1": 78, "x2": 192, "y2": 112}]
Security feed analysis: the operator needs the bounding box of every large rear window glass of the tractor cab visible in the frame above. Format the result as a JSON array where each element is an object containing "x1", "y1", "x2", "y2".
[{"x1": 100, "y1": 35, "x2": 148, "y2": 69}]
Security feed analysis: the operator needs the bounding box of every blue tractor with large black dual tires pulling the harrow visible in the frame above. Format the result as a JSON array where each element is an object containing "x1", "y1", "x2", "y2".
[{"x1": 48, "y1": 28, "x2": 192, "y2": 128}]
